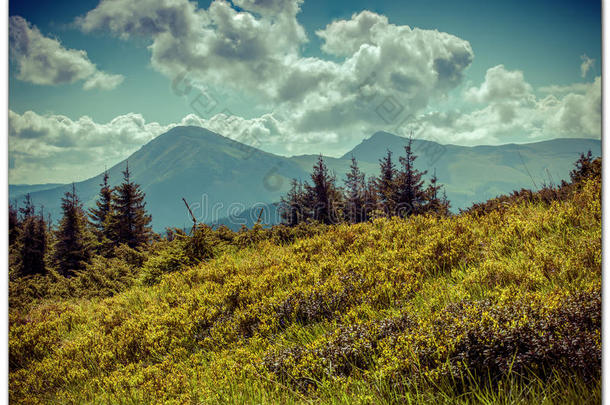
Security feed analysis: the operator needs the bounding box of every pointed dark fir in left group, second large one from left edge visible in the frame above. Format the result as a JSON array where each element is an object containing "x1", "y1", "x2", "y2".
[{"x1": 53, "y1": 183, "x2": 91, "y2": 277}]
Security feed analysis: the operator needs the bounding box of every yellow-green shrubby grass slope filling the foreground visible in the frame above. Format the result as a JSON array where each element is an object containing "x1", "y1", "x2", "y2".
[{"x1": 9, "y1": 181, "x2": 601, "y2": 403}]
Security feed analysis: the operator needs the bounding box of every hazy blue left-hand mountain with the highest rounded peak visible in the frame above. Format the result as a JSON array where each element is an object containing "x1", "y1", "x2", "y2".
[{"x1": 20, "y1": 127, "x2": 306, "y2": 231}]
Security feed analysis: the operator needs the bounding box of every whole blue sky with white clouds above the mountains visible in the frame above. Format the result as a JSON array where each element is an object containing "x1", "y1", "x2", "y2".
[{"x1": 9, "y1": 0, "x2": 601, "y2": 184}]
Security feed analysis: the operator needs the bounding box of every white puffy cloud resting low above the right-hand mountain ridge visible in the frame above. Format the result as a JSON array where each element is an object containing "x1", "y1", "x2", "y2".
[{"x1": 401, "y1": 66, "x2": 601, "y2": 145}]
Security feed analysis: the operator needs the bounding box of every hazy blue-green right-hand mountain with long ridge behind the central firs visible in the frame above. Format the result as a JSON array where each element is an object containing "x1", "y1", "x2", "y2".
[{"x1": 342, "y1": 132, "x2": 601, "y2": 210}]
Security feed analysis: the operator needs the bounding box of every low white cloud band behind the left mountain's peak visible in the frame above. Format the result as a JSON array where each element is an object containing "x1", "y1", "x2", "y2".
[{"x1": 8, "y1": 110, "x2": 294, "y2": 183}]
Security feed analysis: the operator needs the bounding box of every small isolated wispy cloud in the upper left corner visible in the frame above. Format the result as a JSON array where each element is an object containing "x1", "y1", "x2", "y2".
[{"x1": 9, "y1": 16, "x2": 123, "y2": 90}]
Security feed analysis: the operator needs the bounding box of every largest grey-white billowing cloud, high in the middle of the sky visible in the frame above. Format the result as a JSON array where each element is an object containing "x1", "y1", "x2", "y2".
[{"x1": 77, "y1": 0, "x2": 474, "y2": 148}]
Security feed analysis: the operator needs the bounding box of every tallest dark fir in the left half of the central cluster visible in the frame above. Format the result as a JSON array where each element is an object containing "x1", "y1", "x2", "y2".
[{"x1": 305, "y1": 155, "x2": 341, "y2": 224}]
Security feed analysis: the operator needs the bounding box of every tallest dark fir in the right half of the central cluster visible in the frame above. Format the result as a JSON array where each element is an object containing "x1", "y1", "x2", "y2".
[{"x1": 396, "y1": 138, "x2": 427, "y2": 217}]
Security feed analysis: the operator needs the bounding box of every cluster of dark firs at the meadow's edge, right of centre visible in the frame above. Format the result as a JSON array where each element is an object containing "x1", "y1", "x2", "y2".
[{"x1": 281, "y1": 139, "x2": 449, "y2": 226}]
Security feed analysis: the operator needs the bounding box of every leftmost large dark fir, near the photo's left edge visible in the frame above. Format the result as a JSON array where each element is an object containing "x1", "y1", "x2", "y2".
[{"x1": 16, "y1": 194, "x2": 47, "y2": 275}]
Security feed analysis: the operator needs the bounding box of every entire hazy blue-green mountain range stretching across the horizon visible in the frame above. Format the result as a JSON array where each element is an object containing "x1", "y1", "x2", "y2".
[{"x1": 9, "y1": 127, "x2": 601, "y2": 231}]
